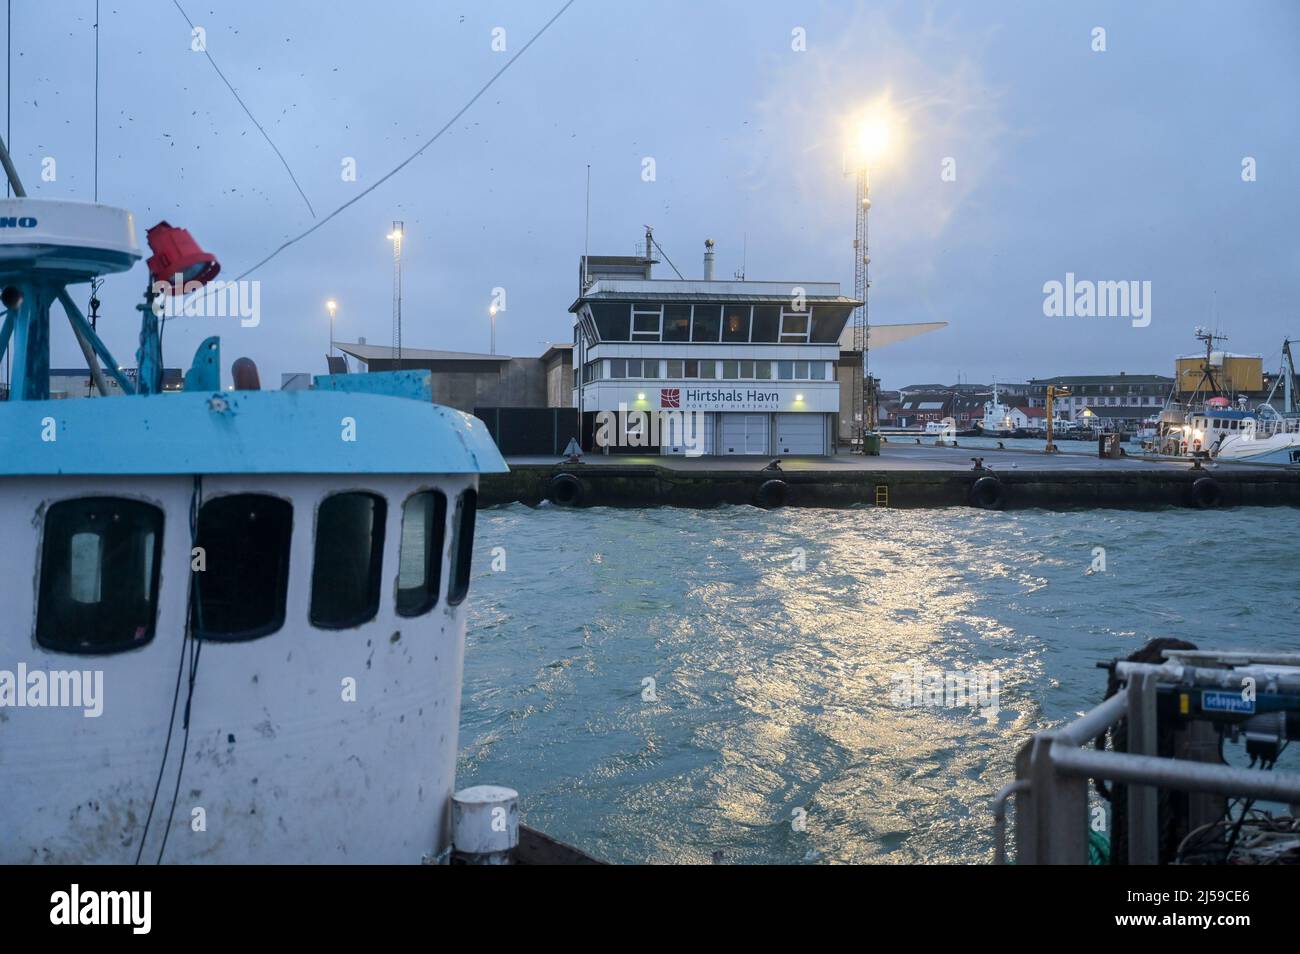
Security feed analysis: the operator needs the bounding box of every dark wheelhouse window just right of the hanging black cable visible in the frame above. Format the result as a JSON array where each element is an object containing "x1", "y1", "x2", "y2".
[{"x1": 194, "y1": 494, "x2": 294, "y2": 642}]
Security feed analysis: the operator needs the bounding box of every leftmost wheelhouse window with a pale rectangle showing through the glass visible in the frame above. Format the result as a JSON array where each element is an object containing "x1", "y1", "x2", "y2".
[{"x1": 36, "y1": 496, "x2": 163, "y2": 654}]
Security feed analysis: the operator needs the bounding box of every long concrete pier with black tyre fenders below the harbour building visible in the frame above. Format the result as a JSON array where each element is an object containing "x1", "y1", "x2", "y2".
[{"x1": 478, "y1": 443, "x2": 1300, "y2": 509}]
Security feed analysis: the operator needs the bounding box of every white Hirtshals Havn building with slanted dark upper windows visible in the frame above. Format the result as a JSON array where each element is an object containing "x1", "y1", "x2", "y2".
[{"x1": 569, "y1": 240, "x2": 861, "y2": 456}]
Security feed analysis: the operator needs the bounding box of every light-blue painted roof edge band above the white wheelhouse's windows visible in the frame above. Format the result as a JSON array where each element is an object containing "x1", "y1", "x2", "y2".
[{"x1": 0, "y1": 389, "x2": 507, "y2": 477}]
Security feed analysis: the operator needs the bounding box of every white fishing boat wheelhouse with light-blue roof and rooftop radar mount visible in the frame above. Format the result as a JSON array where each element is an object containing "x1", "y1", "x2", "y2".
[{"x1": 0, "y1": 199, "x2": 506, "y2": 863}]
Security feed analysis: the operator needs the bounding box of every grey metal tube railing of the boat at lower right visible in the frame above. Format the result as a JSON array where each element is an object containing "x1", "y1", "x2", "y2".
[{"x1": 993, "y1": 660, "x2": 1300, "y2": 864}]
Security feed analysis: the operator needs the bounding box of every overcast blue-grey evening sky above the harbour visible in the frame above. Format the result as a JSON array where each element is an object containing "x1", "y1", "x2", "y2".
[{"x1": 9, "y1": 0, "x2": 1300, "y2": 387}]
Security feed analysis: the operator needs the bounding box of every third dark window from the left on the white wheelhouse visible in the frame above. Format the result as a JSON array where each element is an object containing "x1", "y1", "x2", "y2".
[{"x1": 308, "y1": 493, "x2": 387, "y2": 629}]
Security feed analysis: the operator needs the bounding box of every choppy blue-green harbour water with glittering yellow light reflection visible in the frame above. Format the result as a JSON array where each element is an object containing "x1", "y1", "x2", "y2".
[{"x1": 458, "y1": 506, "x2": 1300, "y2": 863}]
